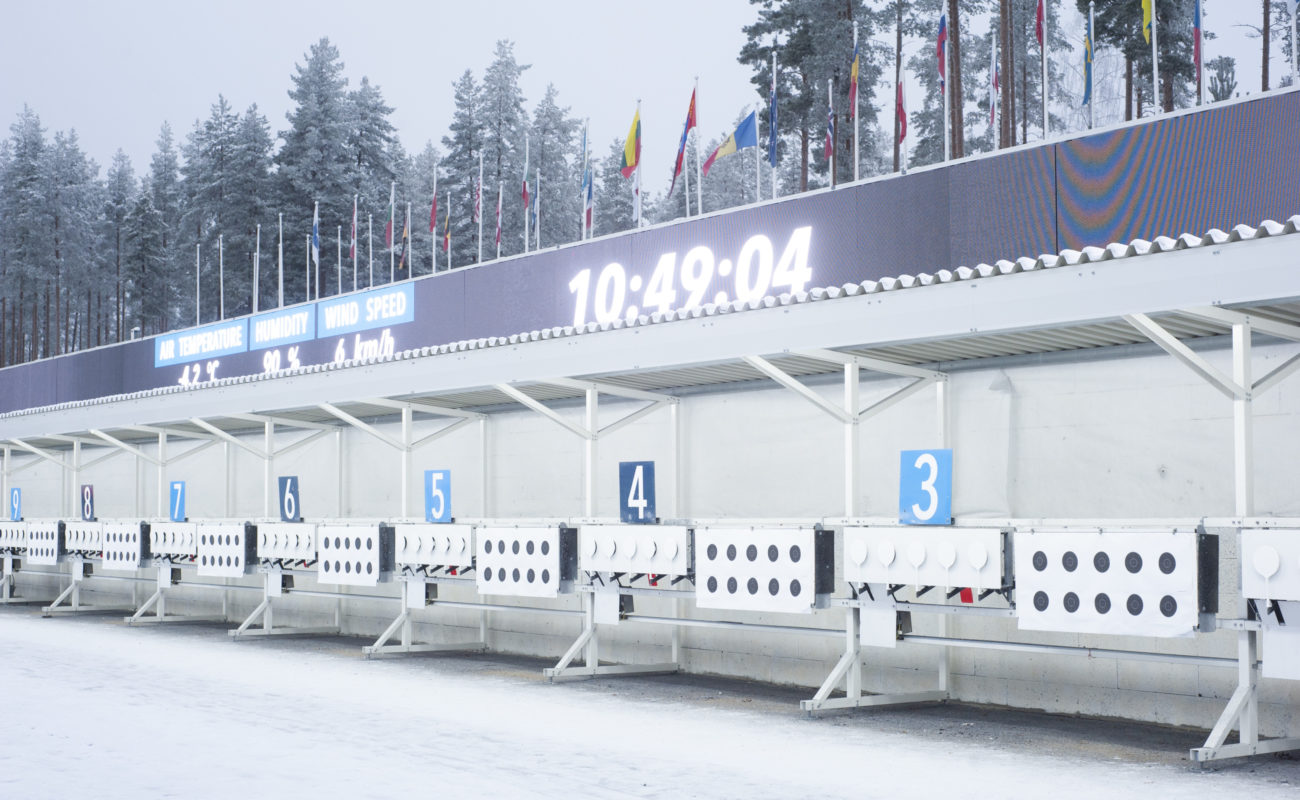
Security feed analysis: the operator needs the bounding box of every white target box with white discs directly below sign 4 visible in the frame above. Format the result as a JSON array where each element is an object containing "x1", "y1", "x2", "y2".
[{"x1": 577, "y1": 526, "x2": 690, "y2": 576}]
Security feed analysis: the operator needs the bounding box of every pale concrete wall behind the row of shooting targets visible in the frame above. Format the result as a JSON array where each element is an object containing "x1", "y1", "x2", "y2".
[{"x1": 5, "y1": 345, "x2": 1300, "y2": 735}]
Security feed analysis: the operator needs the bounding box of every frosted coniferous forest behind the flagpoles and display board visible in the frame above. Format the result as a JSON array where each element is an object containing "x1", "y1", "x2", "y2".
[{"x1": 0, "y1": 0, "x2": 1294, "y2": 366}]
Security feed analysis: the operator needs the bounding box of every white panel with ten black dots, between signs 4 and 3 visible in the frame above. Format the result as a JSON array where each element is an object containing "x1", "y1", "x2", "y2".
[{"x1": 696, "y1": 528, "x2": 835, "y2": 614}]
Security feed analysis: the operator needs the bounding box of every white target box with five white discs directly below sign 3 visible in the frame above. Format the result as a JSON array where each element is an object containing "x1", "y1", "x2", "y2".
[{"x1": 844, "y1": 527, "x2": 1006, "y2": 589}]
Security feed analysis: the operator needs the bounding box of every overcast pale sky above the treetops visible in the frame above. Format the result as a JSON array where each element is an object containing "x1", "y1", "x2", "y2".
[{"x1": 0, "y1": 0, "x2": 1288, "y2": 190}]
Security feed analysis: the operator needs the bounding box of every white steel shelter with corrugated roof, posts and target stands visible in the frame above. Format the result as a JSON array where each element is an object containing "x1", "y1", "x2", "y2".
[{"x1": 0, "y1": 217, "x2": 1300, "y2": 761}]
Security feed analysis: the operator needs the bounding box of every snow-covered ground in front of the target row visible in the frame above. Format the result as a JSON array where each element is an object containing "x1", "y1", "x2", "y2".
[{"x1": 0, "y1": 606, "x2": 1300, "y2": 800}]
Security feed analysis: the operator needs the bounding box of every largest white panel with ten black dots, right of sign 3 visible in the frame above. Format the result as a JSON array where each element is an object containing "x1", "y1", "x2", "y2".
[{"x1": 1015, "y1": 528, "x2": 1218, "y2": 636}]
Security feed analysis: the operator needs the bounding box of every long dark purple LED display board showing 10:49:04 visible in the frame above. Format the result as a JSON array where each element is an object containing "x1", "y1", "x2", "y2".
[{"x1": 0, "y1": 92, "x2": 1300, "y2": 412}]
